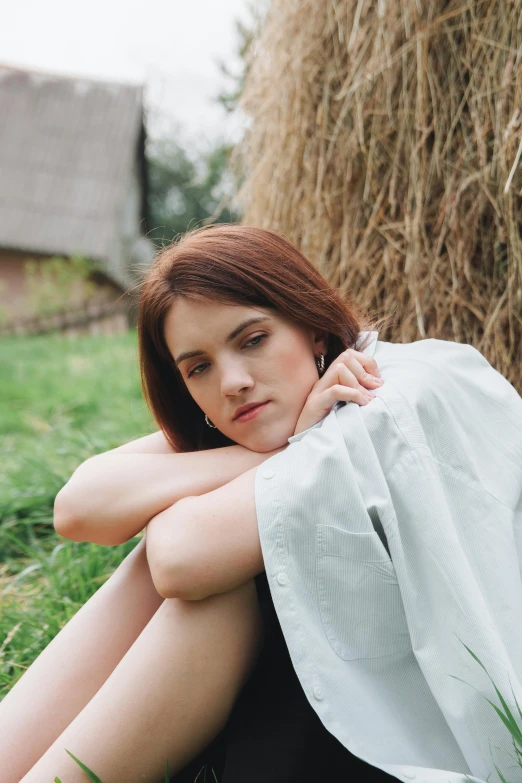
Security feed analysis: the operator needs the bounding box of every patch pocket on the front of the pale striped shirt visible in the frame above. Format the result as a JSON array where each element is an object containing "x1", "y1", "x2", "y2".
[{"x1": 316, "y1": 524, "x2": 412, "y2": 661}]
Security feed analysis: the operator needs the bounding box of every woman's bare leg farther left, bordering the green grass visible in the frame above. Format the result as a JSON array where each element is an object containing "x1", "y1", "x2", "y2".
[{"x1": 0, "y1": 539, "x2": 164, "y2": 783}]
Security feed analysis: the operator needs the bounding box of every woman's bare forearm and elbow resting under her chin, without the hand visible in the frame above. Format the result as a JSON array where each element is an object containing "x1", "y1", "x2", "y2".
[{"x1": 54, "y1": 444, "x2": 286, "y2": 546}]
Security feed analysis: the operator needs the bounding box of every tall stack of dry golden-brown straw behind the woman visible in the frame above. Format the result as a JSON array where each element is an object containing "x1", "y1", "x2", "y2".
[{"x1": 232, "y1": 0, "x2": 522, "y2": 393}]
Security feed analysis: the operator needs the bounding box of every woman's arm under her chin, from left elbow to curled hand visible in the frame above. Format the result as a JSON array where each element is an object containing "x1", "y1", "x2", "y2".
[{"x1": 54, "y1": 349, "x2": 377, "y2": 546}]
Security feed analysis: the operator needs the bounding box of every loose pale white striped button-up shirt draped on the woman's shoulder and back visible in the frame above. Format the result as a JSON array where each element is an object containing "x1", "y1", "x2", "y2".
[{"x1": 255, "y1": 332, "x2": 522, "y2": 783}]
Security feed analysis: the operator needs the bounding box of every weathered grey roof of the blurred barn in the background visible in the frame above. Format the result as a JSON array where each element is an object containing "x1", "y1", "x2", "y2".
[{"x1": 0, "y1": 66, "x2": 149, "y2": 284}]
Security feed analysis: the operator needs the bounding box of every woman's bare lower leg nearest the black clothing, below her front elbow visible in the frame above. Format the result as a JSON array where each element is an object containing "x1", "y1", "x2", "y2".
[{"x1": 20, "y1": 579, "x2": 263, "y2": 783}]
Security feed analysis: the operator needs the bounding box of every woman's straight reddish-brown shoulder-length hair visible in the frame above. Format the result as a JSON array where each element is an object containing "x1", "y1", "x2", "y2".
[{"x1": 138, "y1": 223, "x2": 386, "y2": 451}]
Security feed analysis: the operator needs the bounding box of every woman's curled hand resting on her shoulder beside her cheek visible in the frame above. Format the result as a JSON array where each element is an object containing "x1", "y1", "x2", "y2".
[{"x1": 294, "y1": 348, "x2": 384, "y2": 435}]
